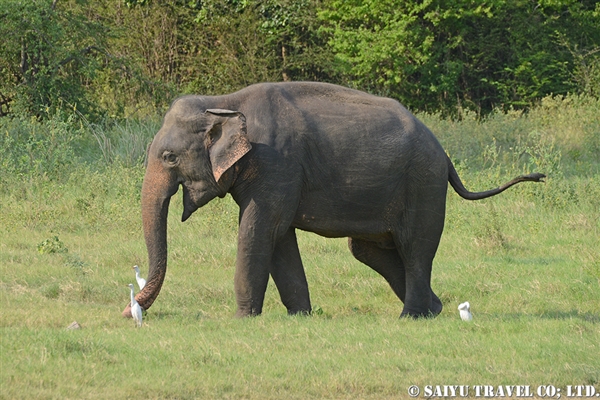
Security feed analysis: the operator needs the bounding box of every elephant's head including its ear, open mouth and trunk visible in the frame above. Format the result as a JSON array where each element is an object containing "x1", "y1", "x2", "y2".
[{"x1": 123, "y1": 102, "x2": 252, "y2": 317}]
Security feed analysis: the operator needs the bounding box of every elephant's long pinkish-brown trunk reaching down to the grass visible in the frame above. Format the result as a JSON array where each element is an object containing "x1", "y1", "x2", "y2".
[{"x1": 123, "y1": 159, "x2": 179, "y2": 317}]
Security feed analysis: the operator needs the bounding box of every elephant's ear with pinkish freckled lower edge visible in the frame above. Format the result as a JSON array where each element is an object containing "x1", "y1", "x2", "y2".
[{"x1": 206, "y1": 109, "x2": 252, "y2": 182}]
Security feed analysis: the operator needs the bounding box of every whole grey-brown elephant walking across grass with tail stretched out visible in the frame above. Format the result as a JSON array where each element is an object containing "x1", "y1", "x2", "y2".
[{"x1": 123, "y1": 82, "x2": 545, "y2": 318}]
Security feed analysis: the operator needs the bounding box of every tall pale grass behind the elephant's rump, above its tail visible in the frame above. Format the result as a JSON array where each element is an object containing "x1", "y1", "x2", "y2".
[{"x1": 419, "y1": 95, "x2": 600, "y2": 176}]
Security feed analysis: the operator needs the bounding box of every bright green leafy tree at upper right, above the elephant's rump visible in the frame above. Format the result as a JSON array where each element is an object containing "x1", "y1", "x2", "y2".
[{"x1": 319, "y1": 0, "x2": 600, "y2": 111}]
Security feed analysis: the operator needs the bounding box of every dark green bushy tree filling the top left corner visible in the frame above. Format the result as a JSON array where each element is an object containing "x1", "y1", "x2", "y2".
[{"x1": 0, "y1": 0, "x2": 104, "y2": 117}]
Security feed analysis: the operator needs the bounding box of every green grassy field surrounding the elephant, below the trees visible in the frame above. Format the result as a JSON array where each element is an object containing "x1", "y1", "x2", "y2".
[{"x1": 0, "y1": 98, "x2": 600, "y2": 399}]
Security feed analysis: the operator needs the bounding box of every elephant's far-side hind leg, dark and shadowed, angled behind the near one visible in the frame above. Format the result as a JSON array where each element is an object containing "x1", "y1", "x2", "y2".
[{"x1": 348, "y1": 238, "x2": 406, "y2": 303}]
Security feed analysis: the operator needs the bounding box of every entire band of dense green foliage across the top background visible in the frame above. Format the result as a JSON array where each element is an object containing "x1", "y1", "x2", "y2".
[{"x1": 0, "y1": 0, "x2": 600, "y2": 120}]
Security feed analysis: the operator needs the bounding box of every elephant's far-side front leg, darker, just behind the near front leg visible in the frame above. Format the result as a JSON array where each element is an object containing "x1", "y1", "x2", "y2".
[{"x1": 271, "y1": 228, "x2": 311, "y2": 315}]
